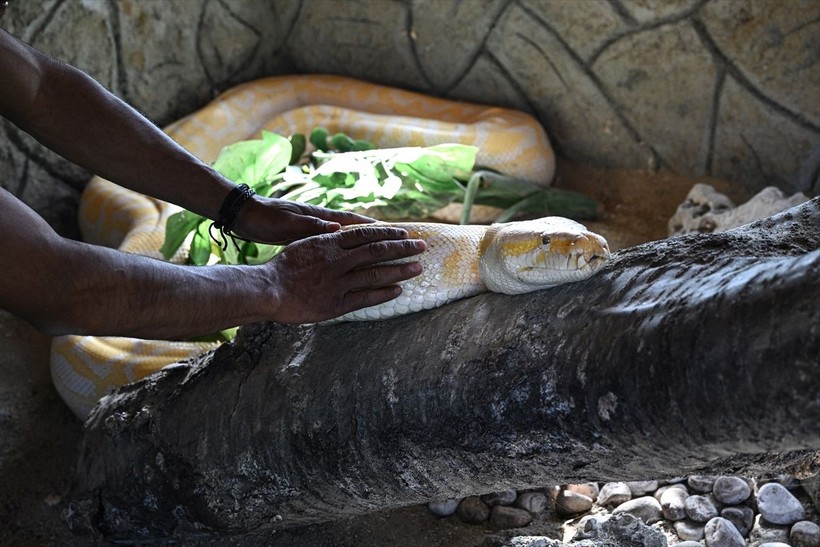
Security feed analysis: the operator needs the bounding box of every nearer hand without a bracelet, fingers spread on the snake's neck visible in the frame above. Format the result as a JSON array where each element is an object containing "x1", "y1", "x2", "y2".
[{"x1": 266, "y1": 225, "x2": 426, "y2": 323}]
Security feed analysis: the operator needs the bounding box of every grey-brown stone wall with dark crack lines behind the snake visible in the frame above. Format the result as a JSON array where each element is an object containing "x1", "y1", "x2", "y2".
[{"x1": 0, "y1": 0, "x2": 820, "y2": 232}]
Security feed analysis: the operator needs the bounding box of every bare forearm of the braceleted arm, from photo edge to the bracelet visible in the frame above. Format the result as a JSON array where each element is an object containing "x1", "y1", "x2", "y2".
[{"x1": 0, "y1": 31, "x2": 232, "y2": 222}]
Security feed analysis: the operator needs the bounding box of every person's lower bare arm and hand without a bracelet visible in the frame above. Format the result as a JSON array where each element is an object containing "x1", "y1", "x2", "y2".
[{"x1": 0, "y1": 189, "x2": 424, "y2": 339}]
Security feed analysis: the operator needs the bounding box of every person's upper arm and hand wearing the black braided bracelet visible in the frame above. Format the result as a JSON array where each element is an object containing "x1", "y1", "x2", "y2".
[{"x1": 0, "y1": 30, "x2": 370, "y2": 243}]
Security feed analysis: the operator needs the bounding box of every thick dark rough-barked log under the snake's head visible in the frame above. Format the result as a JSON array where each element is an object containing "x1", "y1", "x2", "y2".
[{"x1": 71, "y1": 198, "x2": 820, "y2": 538}]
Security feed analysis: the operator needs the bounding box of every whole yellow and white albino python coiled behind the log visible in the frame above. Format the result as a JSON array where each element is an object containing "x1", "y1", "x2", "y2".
[{"x1": 51, "y1": 75, "x2": 609, "y2": 418}]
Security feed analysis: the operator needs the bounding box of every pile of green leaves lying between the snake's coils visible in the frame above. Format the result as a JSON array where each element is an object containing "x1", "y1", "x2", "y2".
[{"x1": 160, "y1": 128, "x2": 597, "y2": 265}]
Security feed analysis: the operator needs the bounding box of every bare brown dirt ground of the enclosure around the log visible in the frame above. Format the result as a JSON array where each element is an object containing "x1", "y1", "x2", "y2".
[{"x1": 0, "y1": 164, "x2": 749, "y2": 547}]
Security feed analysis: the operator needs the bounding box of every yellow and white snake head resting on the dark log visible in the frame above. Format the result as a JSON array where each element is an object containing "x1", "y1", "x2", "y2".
[{"x1": 479, "y1": 217, "x2": 610, "y2": 294}]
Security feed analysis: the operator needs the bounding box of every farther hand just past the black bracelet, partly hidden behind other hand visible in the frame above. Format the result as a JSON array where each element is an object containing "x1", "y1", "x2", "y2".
[{"x1": 234, "y1": 196, "x2": 373, "y2": 244}]
